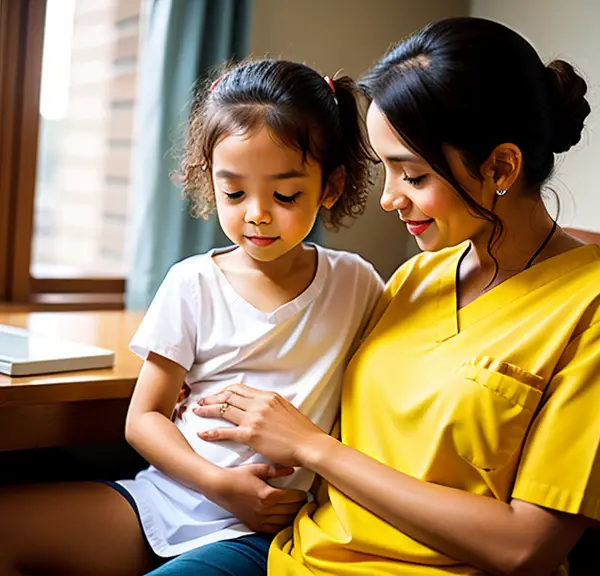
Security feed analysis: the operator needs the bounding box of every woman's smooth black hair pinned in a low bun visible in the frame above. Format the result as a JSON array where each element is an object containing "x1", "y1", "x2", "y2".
[{"x1": 359, "y1": 18, "x2": 590, "y2": 254}]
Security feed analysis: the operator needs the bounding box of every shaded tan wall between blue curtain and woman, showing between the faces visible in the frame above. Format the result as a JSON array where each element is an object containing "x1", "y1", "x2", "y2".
[{"x1": 250, "y1": 0, "x2": 468, "y2": 278}]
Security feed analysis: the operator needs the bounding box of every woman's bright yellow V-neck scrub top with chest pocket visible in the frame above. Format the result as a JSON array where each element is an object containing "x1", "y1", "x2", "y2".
[{"x1": 268, "y1": 244, "x2": 600, "y2": 576}]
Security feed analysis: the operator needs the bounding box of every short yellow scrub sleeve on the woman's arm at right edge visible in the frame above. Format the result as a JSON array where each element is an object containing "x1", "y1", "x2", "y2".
[{"x1": 512, "y1": 322, "x2": 600, "y2": 520}]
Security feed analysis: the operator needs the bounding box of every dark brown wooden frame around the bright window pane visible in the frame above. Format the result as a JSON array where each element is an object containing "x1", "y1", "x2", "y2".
[{"x1": 0, "y1": 0, "x2": 125, "y2": 310}]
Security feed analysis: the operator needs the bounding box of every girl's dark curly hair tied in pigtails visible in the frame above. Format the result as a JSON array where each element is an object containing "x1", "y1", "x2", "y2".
[{"x1": 181, "y1": 59, "x2": 370, "y2": 229}]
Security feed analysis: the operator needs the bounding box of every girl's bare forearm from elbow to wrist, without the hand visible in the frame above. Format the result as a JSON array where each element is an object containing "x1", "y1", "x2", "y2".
[{"x1": 125, "y1": 412, "x2": 222, "y2": 493}]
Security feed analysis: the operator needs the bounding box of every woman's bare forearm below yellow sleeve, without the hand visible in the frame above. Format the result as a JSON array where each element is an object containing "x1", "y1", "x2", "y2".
[{"x1": 301, "y1": 435, "x2": 576, "y2": 576}]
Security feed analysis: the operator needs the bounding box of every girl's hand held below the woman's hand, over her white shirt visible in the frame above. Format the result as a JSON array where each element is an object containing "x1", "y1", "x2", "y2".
[{"x1": 205, "y1": 464, "x2": 306, "y2": 533}]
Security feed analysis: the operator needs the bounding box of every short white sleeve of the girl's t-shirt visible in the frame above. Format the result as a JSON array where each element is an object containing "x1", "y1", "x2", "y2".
[{"x1": 129, "y1": 264, "x2": 199, "y2": 370}]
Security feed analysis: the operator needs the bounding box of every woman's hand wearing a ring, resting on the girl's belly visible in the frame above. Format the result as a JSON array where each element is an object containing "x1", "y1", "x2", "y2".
[{"x1": 194, "y1": 384, "x2": 327, "y2": 466}]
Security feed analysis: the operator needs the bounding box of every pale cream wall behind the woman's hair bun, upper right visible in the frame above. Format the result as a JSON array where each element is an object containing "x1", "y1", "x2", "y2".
[{"x1": 471, "y1": 0, "x2": 600, "y2": 232}]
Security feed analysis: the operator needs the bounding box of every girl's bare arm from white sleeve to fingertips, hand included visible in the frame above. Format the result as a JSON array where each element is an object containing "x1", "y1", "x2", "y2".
[{"x1": 125, "y1": 353, "x2": 306, "y2": 532}]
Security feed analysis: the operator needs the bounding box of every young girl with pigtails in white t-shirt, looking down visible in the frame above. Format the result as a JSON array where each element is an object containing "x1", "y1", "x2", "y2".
[{"x1": 0, "y1": 60, "x2": 382, "y2": 576}]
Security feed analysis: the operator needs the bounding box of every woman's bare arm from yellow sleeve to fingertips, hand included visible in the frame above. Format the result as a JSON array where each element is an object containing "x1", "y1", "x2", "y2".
[{"x1": 194, "y1": 384, "x2": 590, "y2": 576}]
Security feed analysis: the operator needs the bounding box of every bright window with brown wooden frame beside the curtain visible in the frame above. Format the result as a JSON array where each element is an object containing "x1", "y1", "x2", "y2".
[{"x1": 0, "y1": 0, "x2": 141, "y2": 309}]
